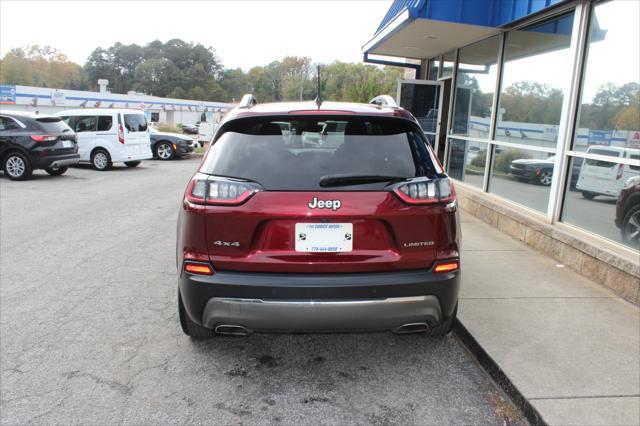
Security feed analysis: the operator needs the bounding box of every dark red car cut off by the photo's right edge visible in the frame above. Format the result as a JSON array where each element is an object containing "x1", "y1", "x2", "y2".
[{"x1": 615, "y1": 176, "x2": 640, "y2": 248}]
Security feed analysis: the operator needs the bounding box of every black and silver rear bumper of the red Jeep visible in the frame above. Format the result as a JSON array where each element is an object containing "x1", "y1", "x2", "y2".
[{"x1": 179, "y1": 270, "x2": 460, "y2": 332}]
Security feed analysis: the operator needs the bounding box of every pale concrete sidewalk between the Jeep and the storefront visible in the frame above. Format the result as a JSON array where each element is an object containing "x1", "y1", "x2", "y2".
[{"x1": 458, "y1": 211, "x2": 640, "y2": 425}]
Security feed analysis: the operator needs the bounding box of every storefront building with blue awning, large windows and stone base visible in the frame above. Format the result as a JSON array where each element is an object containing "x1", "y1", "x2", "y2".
[{"x1": 363, "y1": 0, "x2": 640, "y2": 304}]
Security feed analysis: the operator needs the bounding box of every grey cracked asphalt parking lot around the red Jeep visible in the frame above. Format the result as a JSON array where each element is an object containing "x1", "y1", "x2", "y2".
[{"x1": 0, "y1": 158, "x2": 522, "y2": 425}]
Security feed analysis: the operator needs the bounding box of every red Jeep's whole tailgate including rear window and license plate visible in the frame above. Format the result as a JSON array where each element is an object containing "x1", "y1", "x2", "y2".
[{"x1": 192, "y1": 115, "x2": 457, "y2": 273}]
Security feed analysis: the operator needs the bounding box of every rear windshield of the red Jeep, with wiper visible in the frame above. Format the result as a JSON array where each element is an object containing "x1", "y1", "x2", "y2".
[{"x1": 200, "y1": 116, "x2": 442, "y2": 191}]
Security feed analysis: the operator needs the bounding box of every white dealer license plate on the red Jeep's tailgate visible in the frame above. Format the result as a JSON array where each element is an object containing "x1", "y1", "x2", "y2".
[{"x1": 296, "y1": 223, "x2": 353, "y2": 253}]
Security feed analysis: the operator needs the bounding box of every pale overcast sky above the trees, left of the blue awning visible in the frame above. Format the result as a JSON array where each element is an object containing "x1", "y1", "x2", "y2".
[{"x1": 0, "y1": 0, "x2": 391, "y2": 70}]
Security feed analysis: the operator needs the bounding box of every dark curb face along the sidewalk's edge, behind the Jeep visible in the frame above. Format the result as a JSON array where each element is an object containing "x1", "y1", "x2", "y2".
[{"x1": 453, "y1": 318, "x2": 548, "y2": 426}]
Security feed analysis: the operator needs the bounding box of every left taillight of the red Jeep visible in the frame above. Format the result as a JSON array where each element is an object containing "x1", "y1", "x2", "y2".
[{"x1": 185, "y1": 173, "x2": 262, "y2": 206}]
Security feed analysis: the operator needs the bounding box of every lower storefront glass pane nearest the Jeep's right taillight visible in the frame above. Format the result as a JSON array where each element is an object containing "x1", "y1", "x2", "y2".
[{"x1": 447, "y1": 139, "x2": 488, "y2": 188}]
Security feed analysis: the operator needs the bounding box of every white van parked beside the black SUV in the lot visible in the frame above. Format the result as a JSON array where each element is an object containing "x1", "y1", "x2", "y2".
[{"x1": 56, "y1": 108, "x2": 153, "y2": 170}]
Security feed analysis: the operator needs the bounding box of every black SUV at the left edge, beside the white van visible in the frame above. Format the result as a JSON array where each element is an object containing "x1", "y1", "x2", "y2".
[{"x1": 0, "y1": 110, "x2": 80, "y2": 180}]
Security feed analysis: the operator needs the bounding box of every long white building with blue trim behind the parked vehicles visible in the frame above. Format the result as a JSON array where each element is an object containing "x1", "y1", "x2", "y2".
[{"x1": 0, "y1": 80, "x2": 234, "y2": 126}]
